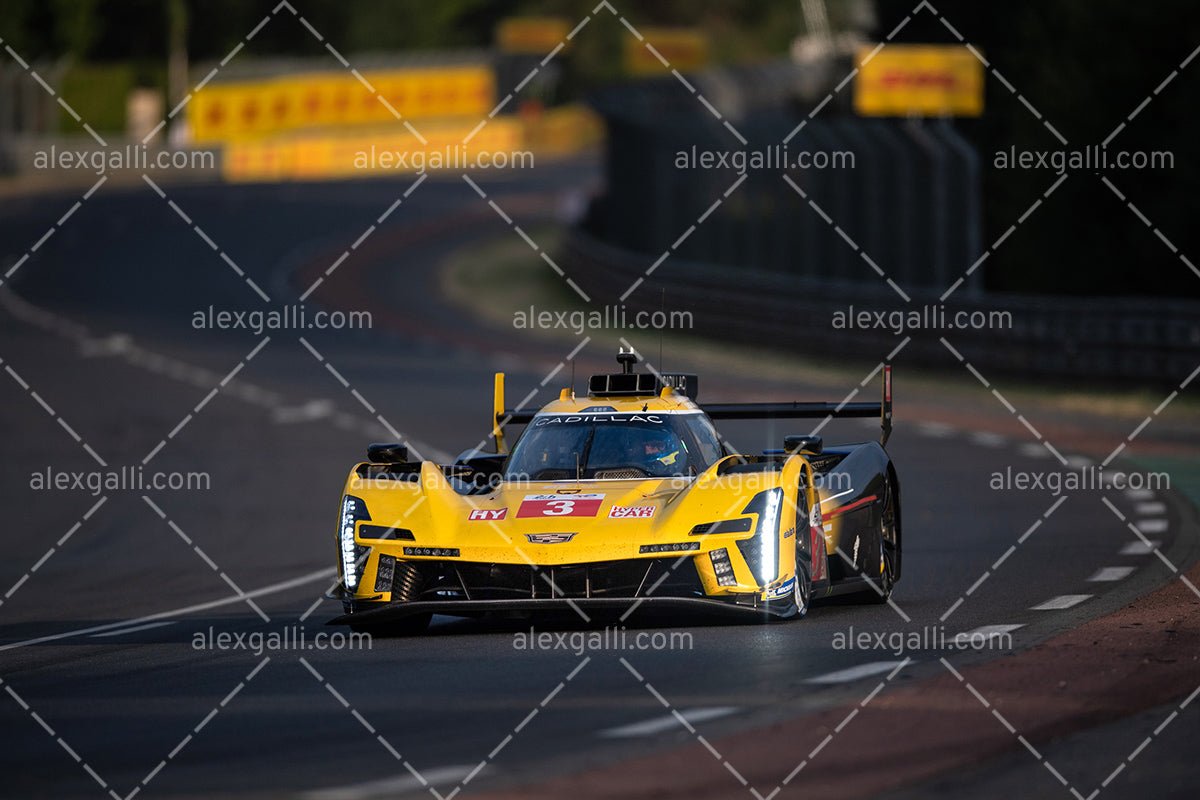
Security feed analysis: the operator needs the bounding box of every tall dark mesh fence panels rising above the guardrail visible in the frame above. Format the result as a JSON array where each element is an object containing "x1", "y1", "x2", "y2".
[{"x1": 586, "y1": 61, "x2": 982, "y2": 291}]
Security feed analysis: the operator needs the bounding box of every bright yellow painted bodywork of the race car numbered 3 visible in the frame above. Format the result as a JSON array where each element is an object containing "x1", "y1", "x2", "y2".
[{"x1": 343, "y1": 407, "x2": 815, "y2": 600}]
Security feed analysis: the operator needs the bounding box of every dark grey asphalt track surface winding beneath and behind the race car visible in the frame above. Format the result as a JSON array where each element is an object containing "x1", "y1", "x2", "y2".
[{"x1": 0, "y1": 159, "x2": 1196, "y2": 798}]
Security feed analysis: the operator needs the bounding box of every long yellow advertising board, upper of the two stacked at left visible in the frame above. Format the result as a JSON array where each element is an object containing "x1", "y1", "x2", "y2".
[{"x1": 187, "y1": 66, "x2": 496, "y2": 144}]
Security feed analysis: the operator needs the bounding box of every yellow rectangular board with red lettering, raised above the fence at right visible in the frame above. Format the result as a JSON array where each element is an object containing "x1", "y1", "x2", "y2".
[{"x1": 854, "y1": 44, "x2": 984, "y2": 116}]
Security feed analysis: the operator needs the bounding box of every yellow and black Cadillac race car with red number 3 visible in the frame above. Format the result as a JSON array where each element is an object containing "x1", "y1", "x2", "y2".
[{"x1": 331, "y1": 353, "x2": 902, "y2": 632}]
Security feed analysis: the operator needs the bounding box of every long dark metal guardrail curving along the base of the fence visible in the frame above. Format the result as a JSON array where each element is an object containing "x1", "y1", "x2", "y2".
[{"x1": 559, "y1": 229, "x2": 1200, "y2": 387}]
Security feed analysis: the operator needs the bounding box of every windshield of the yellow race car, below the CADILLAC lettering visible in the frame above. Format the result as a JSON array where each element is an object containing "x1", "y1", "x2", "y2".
[{"x1": 505, "y1": 411, "x2": 720, "y2": 481}]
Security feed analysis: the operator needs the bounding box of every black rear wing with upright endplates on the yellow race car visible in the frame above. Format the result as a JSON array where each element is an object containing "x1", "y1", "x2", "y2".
[{"x1": 492, "y1": 363, "x2": 892, "y2": 452}]
